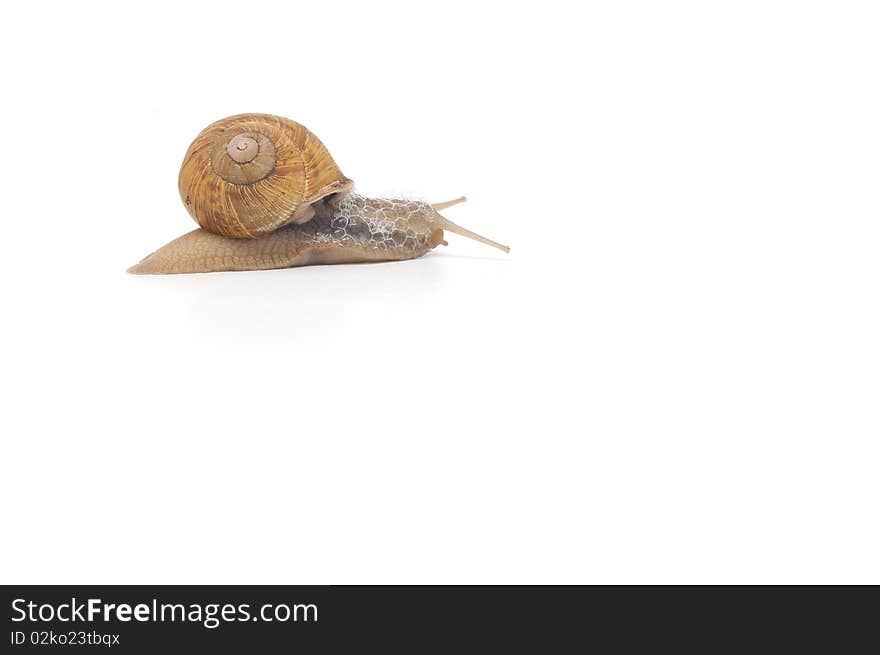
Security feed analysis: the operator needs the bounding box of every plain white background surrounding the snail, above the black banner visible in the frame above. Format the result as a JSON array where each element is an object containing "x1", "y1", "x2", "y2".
[{"x1": 0, "y1": 1, "x2": 880, "y2": 583}]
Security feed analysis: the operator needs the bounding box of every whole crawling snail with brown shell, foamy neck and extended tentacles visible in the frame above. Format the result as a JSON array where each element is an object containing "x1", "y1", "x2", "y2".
[{"x1": 129, "y1": 114, "x2": 510, "y2": 274}]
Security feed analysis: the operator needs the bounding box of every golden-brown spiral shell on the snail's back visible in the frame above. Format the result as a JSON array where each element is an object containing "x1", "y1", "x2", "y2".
[{"x1": 178, "y1": 114, "x2": 353, "y2": 238}]
